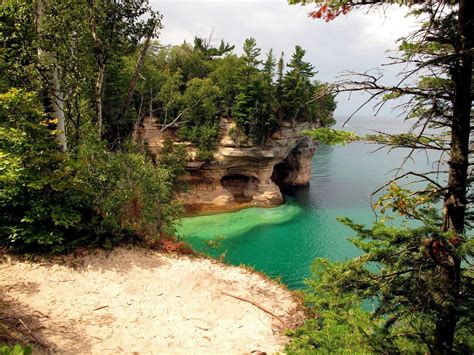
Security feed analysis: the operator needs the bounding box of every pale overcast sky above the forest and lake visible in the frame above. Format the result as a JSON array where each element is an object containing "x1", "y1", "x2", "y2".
[{"x1": 151, "y1": 0, "x2": 413, "y2": 116}]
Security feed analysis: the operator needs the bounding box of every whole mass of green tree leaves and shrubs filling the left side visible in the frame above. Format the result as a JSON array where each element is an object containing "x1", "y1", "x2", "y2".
[{"x1": 0, "y1": 0, "x2": 183, "y2": 252}]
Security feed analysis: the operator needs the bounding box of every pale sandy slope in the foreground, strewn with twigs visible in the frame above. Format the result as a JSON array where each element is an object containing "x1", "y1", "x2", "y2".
[{"x1": 0, "y1": 248, "x2": 302, "y2": 354}]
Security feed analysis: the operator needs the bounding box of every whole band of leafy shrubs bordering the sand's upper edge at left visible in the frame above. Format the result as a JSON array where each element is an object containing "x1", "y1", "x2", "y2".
[{"x1": 0, "y1": 89, "x2": 182, "y2": 252}]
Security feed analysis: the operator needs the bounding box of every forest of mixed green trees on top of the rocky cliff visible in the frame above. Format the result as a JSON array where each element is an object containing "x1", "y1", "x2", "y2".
[{"x1": 130, "y1": 37, "x2": 335, "y2": 155}]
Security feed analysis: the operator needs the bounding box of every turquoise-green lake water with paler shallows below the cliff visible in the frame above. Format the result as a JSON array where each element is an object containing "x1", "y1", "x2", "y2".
[{"x1": 178, "y1": 119, "x2": 444, "y2": 289}]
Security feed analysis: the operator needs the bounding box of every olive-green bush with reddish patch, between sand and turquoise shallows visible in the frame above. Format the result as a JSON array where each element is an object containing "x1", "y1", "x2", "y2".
[{"x1": 78, "y1": 135, "x2": 183, "y2": 240}]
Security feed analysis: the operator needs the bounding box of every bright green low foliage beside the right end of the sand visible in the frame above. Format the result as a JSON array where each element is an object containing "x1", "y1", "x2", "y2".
[{"x1": 285, "y1": 259, "x2": 382, "y2": 354}]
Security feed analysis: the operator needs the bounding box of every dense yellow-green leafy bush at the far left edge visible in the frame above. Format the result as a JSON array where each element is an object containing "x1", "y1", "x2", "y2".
[{"x1": 0, "y1": 89, "x2": 86, "y2": 251}]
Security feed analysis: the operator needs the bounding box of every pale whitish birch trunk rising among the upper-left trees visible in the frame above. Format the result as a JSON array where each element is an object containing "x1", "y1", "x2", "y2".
[{"x1": 35, "y1": 0, "x2": 67, "y2": 152}]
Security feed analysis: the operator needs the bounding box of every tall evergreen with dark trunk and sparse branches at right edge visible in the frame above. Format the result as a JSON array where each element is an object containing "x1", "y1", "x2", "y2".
[{"x1": 286, "y1": 0, "x2": 474, "y2": 354}]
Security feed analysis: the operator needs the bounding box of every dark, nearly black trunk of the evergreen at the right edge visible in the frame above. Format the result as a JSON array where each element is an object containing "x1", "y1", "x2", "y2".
[{"x1": 434, "y1": 0, "x2": 474, "y2": 354}]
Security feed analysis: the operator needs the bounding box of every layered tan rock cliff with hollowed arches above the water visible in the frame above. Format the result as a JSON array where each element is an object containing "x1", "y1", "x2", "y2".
[{"x1": 138, "y1": 119, "x2": 316, "y2": 212}]
